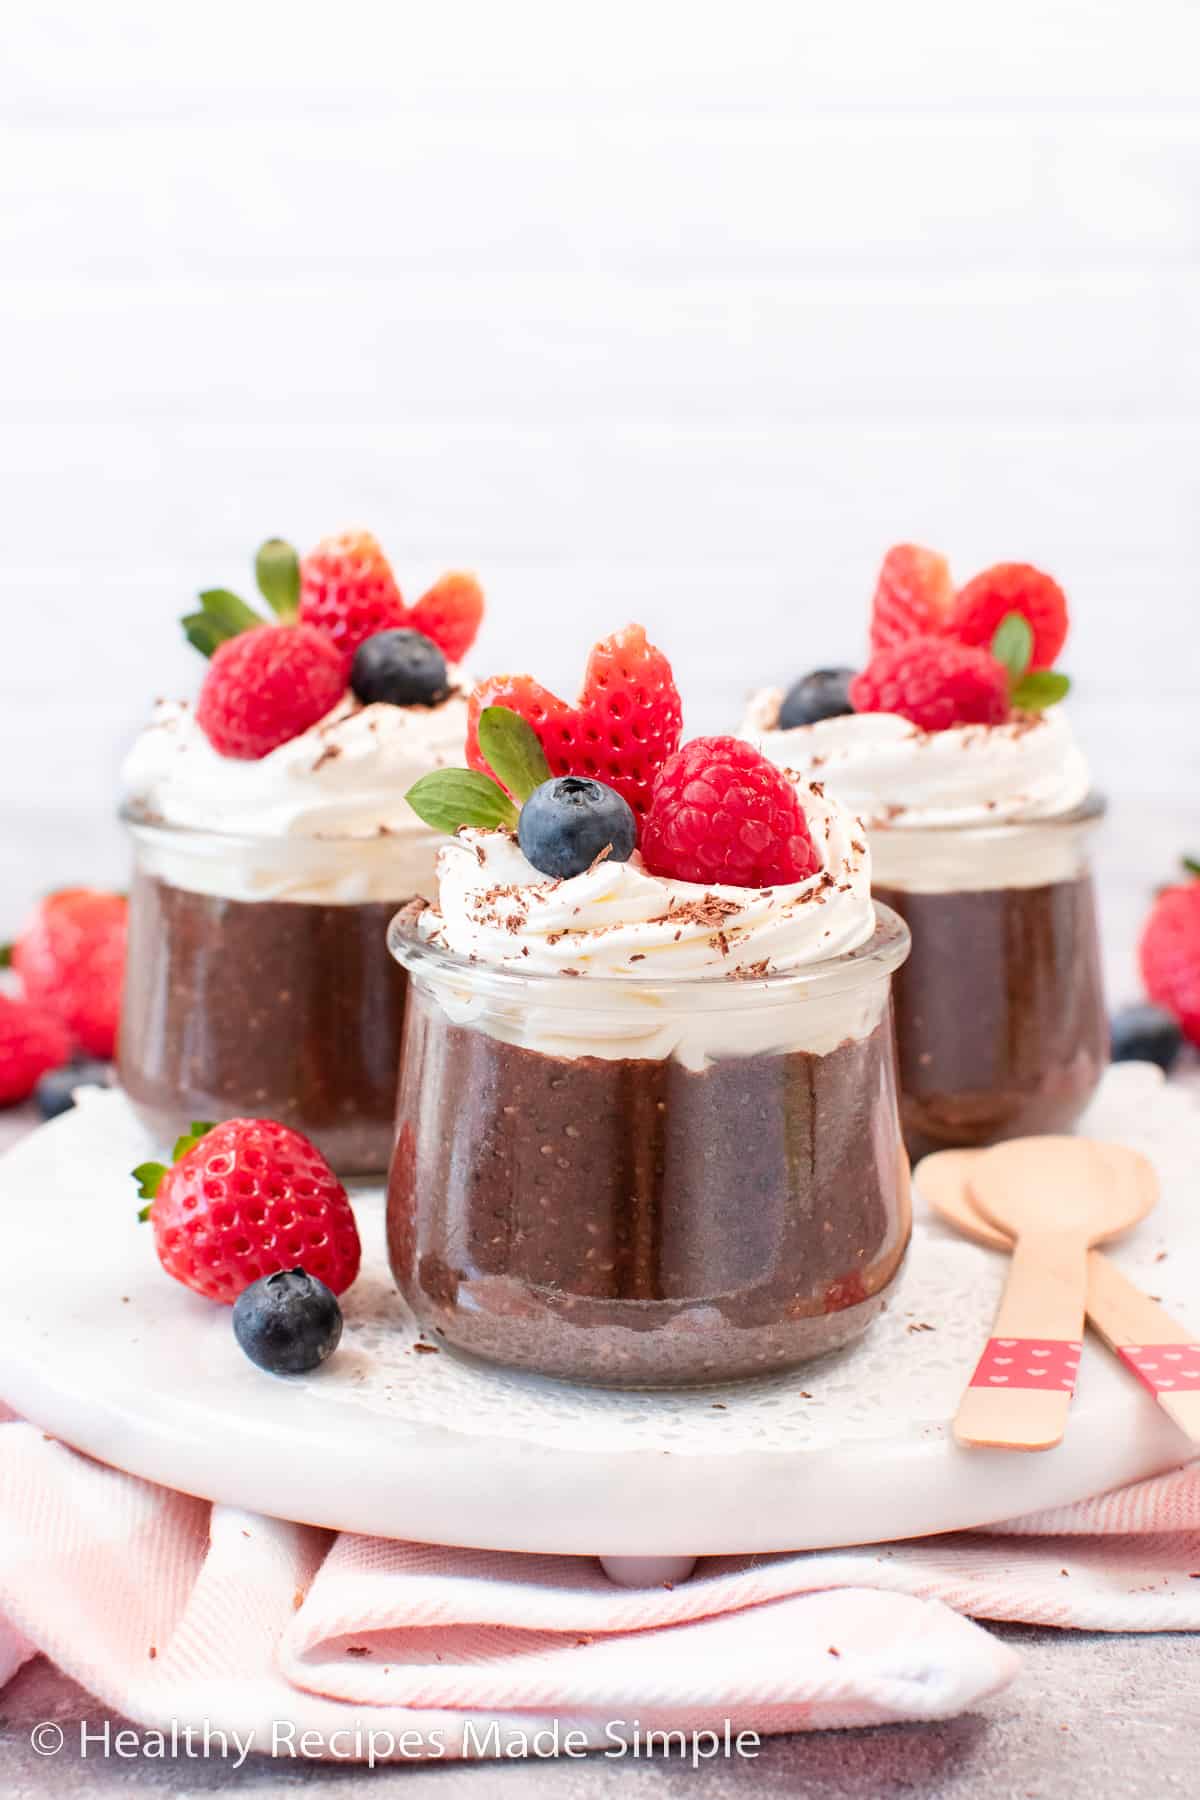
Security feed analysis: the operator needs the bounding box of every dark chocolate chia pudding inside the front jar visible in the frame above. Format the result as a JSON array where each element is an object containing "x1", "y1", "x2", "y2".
[{"x1": 389, "y1": 1003, "x2": 909, "y2": 1386}]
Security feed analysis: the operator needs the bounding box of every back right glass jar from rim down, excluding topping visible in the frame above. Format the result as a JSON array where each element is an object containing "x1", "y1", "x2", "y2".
[{"x1": 871, "y1": 797, "x2": 1108, "y2": 1161}]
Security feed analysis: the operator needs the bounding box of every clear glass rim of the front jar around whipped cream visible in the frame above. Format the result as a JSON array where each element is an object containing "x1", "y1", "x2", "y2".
[{"x1": 387, "y1": 900, "x2": 912, "y2": 1010}]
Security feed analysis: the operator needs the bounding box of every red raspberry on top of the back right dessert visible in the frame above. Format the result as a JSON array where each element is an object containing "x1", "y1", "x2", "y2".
[{"x1": 849, "y1": 637, "x2": 1009, "y2": 731}]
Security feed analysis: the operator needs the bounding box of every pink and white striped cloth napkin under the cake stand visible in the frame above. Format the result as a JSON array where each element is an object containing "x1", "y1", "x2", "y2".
[{"x1": 0, "y1": 1420, "x2": 1200, "y2": 1760}]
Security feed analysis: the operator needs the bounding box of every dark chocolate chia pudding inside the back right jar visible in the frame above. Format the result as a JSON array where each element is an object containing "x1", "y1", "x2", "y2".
[{"x1": 876, "y1": 875, "x2": 1108, "y2": 1159}]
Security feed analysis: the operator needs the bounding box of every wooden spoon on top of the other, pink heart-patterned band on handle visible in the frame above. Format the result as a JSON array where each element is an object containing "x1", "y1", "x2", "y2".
[{"x1": 954, "y1": 1138, "x2": 1155, "y2": 1451}]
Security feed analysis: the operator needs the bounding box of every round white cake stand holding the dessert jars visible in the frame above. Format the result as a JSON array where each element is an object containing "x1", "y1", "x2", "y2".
[{"x1": 0, "y1": 1064, "x2": 1200, "y2": 1580}]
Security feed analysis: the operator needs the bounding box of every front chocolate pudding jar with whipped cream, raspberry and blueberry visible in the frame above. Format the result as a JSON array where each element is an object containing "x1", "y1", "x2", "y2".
[{"x1": 387, "y1": 640, "x2": 910, "y2": 1388}]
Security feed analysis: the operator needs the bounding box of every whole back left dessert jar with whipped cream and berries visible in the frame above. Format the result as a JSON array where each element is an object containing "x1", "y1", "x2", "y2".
[{"x1": 119, "y1": 535, "x2": 479, "y2": 1175}]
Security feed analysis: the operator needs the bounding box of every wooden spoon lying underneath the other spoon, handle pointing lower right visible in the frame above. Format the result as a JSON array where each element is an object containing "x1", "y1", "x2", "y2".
[{"x1": 918, "y1": 1150, "x2": 1200, "y2": 1444}]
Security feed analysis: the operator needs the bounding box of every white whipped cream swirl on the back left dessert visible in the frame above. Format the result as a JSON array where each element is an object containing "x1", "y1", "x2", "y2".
[{"x1": 122, "y1": 668, "x2": 470, "y2": 904}]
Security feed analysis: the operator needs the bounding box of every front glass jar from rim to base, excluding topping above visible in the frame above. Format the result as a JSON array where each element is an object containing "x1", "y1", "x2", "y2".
[{"x1": 387, "y1": 907, "x2": 910, "y2": 1388}]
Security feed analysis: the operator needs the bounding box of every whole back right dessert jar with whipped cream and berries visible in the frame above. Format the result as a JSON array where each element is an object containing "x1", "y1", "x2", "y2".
[{"x1": 743, "y1": 545, "x2": 1108, "y2": 1157}]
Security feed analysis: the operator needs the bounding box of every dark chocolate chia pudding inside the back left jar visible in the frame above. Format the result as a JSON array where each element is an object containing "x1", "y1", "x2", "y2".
[{"x1": 121, "y1": 873, "x2": 407, "y2": 1174}]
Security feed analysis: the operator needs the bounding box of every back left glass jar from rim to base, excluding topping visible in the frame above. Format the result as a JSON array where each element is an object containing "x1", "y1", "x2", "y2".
[{"x1": 119, "y1": 810, "x2": 422, "y2": 1175}]
